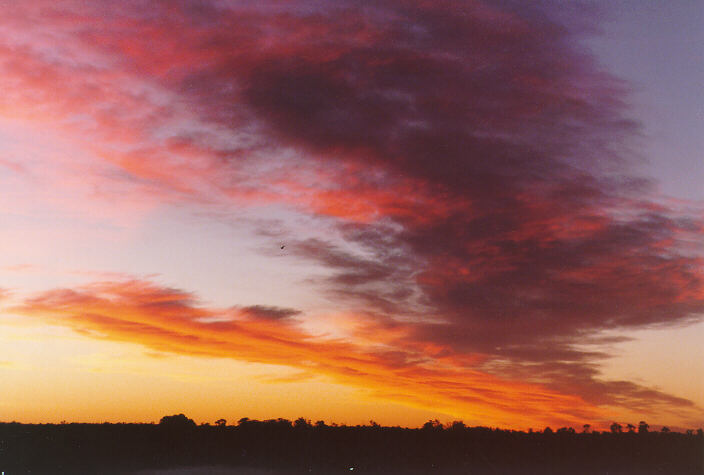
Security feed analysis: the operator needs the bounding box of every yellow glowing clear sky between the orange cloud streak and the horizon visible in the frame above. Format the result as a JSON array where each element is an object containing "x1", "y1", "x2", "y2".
[{"x1": 0, "y1": 325, "x2": 449, "y2": 427}]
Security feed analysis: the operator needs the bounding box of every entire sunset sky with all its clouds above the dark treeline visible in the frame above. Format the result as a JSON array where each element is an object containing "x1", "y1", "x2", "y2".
[{"x1": 0, "y1": 0, "x2": 704, "y2": 430}]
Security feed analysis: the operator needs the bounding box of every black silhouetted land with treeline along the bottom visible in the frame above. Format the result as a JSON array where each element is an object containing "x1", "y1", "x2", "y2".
[{"x1": 0, "y1": 414, "x2": 704, "y2": 475}]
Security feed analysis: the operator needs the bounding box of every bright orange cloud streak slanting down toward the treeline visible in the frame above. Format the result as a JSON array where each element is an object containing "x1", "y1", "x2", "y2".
[{"x1": 13, "y1": 280, "x2": 602, "y2": 426}]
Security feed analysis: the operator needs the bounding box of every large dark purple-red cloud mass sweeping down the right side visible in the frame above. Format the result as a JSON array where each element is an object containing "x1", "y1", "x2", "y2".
[{"x1": 40, "y1": 0, "x2": 704, "y2": 416}]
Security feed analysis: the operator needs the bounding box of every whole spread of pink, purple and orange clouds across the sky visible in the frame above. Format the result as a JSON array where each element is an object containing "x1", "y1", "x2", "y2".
[{"x1": 0, "y1": 1, "x2": 704, "y2": 428}]
